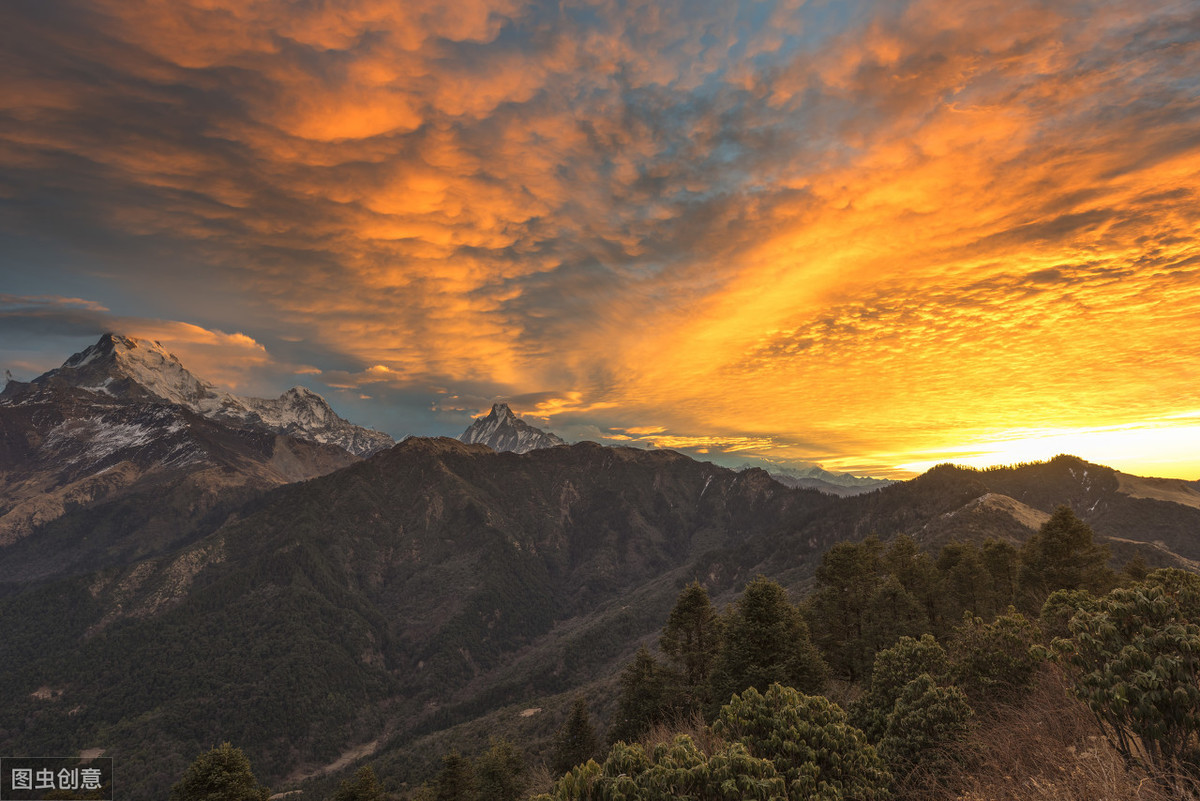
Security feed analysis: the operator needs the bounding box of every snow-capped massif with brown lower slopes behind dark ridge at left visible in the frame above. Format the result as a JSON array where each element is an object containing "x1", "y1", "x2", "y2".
[{"x1": 0, "y1": 335, "x2": 392, "y2": 591}]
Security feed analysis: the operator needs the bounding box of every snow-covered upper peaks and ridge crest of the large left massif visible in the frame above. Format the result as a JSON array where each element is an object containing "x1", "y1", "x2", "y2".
[{"x1": 22, "y1": 333, "x2": 395, "y2": 457}]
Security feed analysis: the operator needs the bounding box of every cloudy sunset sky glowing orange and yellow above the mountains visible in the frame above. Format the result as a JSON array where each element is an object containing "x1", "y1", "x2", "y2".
[{"x1": 0, "y1": 0, "x2": 1200, "y2": 480}]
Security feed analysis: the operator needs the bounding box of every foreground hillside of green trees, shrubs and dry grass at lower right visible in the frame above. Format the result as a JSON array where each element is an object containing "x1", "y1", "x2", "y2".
[{"x1": 173, "y1": 507, "x2": 1200, "y2": 801}]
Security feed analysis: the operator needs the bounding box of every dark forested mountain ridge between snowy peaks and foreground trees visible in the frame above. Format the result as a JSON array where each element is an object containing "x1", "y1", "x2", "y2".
[{"x1": 0, "y1": 412, "x2": 1200, "y2": 800}]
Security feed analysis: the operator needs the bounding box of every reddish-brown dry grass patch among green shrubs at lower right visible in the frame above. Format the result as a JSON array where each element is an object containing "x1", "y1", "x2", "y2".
[{"x1": 899, "y1": 667, "x2": 1172, "y2": 801}]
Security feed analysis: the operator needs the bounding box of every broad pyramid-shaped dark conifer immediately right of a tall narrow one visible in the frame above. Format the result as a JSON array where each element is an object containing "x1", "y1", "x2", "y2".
[{"x1": 713, "y1": 576, "x2": 828, "y2": 701}]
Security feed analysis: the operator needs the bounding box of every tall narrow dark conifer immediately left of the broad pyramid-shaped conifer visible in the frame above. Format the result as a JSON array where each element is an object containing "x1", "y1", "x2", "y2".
[{"x1": 659, "y1": 582, "x2": 721, "y2": 712}]
